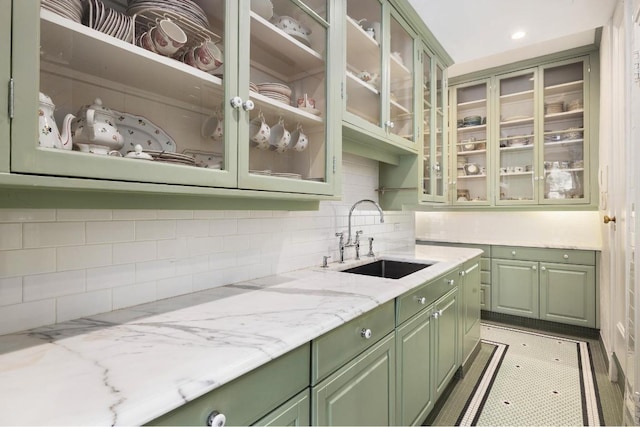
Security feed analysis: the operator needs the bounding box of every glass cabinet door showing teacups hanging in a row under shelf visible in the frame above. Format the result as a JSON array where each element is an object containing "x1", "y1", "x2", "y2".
[{"x1": 238, "y1": 0, "x2": 334, "y2": 193}]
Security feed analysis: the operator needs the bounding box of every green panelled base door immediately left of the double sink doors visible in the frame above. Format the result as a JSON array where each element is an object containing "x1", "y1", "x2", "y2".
[{"x1": 311, "y1": 333, "x2": 396, "y2": 426}]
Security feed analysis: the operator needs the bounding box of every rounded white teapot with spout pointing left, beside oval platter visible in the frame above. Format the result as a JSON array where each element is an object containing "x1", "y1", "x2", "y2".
[{"x1": 71, "y1": 98, "x2": 124, "y2": 154}]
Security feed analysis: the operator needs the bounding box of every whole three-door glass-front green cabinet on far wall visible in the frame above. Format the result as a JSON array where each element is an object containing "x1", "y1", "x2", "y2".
[{"x1": 450, "y1": 50, "x2": 598, "y2": 208}]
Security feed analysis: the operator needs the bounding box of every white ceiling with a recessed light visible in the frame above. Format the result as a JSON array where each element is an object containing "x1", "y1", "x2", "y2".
[{"x1": 409, "y1": 0, "x2": 618, "y2": 77}]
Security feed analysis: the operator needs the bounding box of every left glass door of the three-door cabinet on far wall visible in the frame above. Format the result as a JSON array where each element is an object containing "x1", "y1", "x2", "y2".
[{"x1": 451, "y1": 81, "x2": 490, "y2": 205}]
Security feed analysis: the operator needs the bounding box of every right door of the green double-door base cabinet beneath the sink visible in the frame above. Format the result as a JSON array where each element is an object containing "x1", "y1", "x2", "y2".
[{"x1": 432, "y1": 288, "x2": 460, "y2": 400}]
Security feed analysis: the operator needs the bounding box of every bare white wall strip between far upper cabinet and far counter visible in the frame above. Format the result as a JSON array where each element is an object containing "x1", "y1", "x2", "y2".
[{"x1": 416, "y1": 211, "x2": 602, "y2": 250}]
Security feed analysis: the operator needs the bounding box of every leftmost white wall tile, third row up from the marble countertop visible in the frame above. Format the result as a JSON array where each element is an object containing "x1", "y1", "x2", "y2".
[{"x1": 0, "y1": 248, "x2": 56, "y2": 277}]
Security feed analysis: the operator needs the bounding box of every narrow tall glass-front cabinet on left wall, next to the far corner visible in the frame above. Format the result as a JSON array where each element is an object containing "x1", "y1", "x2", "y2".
[{"x1": 420, "y1": 47, "x2": 448, "y2": 202}]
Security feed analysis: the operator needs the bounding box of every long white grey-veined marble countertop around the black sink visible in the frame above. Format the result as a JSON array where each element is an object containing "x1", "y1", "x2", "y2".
[{"x1": 0, "y1": 245, "x2": 481, "y2": 425}]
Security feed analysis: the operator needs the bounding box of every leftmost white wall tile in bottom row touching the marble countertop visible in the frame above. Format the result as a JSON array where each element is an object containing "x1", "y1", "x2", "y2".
[{"x1": 0, "y1": 299, "x2": 56, "y2": 335}]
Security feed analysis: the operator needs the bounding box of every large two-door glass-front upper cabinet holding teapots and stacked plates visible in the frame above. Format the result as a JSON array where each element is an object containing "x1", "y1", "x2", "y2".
[{"x1": 11, "y1": 0, "x2": 341, "y2": 194}]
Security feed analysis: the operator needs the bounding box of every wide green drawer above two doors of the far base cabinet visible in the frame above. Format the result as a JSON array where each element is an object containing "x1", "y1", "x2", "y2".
[{"x1": 493, "y1": 246, "x2": 596, "y2": 265}]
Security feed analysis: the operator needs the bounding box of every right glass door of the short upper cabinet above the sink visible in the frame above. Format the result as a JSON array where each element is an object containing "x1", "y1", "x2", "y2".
[{"x1": 385, "y1": 7, "x2": 416, "y2": 142}]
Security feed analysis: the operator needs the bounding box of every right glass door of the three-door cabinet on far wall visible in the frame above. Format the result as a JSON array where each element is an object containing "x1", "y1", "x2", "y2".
[{"x1": 539, "y1": 60, "x2": 589, "y2": 204}]
